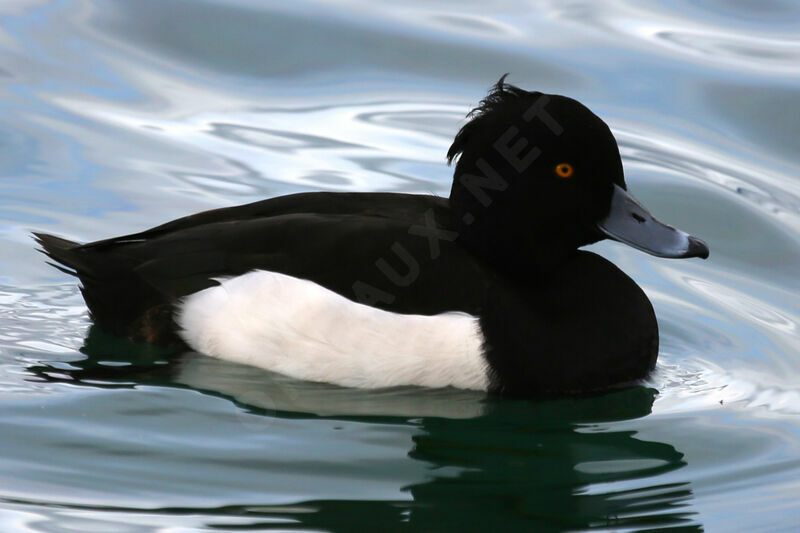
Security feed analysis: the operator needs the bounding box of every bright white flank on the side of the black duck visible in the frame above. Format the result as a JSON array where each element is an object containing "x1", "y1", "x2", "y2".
[{"x1": 177, "y1": 270, "x2": 488, "y2": 390}]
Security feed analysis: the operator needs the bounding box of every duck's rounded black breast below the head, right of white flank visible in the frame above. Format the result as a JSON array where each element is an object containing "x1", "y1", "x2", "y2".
[{"x1": 481, "y1": 251, "x2": 658, "y2": 397}]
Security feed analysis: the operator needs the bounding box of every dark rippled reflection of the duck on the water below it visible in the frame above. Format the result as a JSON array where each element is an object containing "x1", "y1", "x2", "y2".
[{"x1": 29, "y1": 328, "x2": 701, "y2": 531}]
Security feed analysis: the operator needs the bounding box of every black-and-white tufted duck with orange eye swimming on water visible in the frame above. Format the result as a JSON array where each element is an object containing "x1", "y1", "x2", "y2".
[{"x1": 36, "y1": 76, "x2": 708, "y2": 396}]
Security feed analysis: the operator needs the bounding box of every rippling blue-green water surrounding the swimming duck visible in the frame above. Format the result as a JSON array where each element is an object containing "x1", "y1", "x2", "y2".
[{"x1": 0, "y1": 0, "x2": 800, "y2": 532}]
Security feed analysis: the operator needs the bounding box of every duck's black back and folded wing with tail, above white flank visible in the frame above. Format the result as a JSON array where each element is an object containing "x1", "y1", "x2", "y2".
[{"x1": 38, "y1": 193, "x2": 494, "y2": 337}]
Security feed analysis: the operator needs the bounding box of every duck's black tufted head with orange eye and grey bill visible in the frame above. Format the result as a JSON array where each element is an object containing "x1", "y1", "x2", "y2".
[{"x1": 447, "y1": 76, "x2": 708, "y2": 273}]
